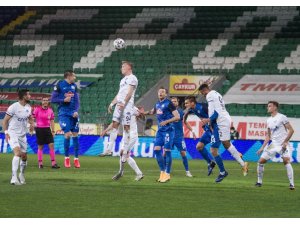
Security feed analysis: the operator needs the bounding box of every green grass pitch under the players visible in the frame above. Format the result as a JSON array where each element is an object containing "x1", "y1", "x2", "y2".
[{"x1": 0, "y1": 154, "x2": 300, "y2": 218}]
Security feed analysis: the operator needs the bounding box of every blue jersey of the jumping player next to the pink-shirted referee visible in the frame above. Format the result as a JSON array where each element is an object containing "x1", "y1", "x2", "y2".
[{"x1": 51, "y1": 80, "x2": 79, "y2": 116}]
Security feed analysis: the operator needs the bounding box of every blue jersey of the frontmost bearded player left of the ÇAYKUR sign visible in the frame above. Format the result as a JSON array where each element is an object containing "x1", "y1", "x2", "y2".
[{"x1": 154, "y1": 98, "x2": 176, "y2": 131}]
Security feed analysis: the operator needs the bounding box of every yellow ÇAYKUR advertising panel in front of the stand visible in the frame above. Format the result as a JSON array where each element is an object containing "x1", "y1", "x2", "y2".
[{"x1": 169, "y1": 75, "x2": 218, "y2": 95}]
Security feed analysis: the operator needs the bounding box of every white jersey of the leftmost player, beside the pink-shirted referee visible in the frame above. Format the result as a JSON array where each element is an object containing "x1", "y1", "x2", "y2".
[{"x1": 6, "y1": 102, "x2": 31, "y2": 136}]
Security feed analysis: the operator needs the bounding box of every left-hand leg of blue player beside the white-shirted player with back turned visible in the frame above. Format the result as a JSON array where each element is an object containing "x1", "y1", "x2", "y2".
[{"x1": 196, "y1": 131, "x2": 216, "y2": 176}]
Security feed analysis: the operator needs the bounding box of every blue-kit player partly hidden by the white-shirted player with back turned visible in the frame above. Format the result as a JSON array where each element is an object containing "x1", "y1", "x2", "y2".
[{"x1": 184, "y1": 96, "x2": 219, "y2": 176}]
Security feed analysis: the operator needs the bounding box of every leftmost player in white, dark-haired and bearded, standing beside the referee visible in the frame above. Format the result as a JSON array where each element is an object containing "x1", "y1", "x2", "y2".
[{"x1": 3, "y1": 89, "x2": 34, "y2": 185}]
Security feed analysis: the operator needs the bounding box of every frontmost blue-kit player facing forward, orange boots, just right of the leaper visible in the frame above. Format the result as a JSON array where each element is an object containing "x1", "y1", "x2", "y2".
[{"x1": 144, "y1": 87, "x2": 180, "y2": 183}]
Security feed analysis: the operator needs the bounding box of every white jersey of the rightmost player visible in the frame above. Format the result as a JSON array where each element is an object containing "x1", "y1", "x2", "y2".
[{"x1": 267, "y1": 113, "x2": 289, "y2": 145}]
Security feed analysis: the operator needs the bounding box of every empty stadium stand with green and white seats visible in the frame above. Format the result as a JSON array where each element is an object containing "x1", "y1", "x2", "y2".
[{"x1": 0, "y1": 7, "x2": 300, "y2": 123}]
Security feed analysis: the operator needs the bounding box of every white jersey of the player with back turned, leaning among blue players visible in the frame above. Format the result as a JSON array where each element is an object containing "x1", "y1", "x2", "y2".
[{"x1": 206, "y1": 90, "x2": 230, "y2": 123}]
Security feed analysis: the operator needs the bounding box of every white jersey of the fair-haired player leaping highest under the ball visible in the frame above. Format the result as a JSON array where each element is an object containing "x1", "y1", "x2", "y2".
[{"x1": 117, "y1": 74, "x2": 138, "y2": 104}]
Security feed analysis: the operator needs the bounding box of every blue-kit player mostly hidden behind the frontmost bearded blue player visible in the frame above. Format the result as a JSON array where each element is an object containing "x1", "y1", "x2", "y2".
[{"x1": 168, "y1": 97, "x2": 193, "y2": 177}]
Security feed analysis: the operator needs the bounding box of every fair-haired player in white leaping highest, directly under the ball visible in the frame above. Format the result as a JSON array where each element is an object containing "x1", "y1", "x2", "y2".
[{"x1": 108, "y1": 61, "x2": 138, "y2": 175}]
